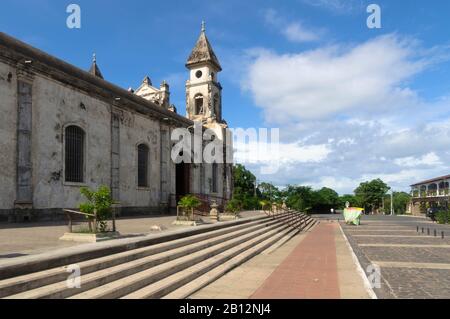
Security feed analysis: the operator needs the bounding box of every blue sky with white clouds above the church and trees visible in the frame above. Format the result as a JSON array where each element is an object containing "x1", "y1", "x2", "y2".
[{"x1": 0, "y1": 0, "x2": 450, "y2": 193}]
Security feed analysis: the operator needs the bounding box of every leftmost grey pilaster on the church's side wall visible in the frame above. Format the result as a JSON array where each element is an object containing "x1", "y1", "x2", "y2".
[{"x1": 15, "y1": 65, "x2": 34, "y2": 210}]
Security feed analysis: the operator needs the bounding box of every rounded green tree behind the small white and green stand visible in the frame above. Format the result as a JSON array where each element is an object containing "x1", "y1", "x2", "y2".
[{"x1": 355, "y1": 179, "x2": 390, "y2": 212}]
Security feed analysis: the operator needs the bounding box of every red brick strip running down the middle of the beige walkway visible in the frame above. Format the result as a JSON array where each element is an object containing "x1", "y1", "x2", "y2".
[{"x1": 251, "y1": 223, "x2": 340, "y2": 299}]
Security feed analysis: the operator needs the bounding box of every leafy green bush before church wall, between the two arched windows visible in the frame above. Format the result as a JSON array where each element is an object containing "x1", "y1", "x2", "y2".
[{"x1": 80, "y1": 186, "x2": 113, "y2": 233}]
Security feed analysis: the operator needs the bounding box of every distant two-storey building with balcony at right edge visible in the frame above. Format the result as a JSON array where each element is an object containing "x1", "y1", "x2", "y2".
[{"x1": 410, "y1": 175, "x2": 450, "y2": 216}]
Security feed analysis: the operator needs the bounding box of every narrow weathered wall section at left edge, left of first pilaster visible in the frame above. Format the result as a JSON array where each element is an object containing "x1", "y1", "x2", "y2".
[{"x1": 0, "y1": 62, "x2": 17, "y2": 210}]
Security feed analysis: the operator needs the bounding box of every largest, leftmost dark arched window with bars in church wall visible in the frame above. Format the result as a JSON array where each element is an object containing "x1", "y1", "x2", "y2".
[{"x1": 65, "y1": 125, "x2": 85, "y2": 183}]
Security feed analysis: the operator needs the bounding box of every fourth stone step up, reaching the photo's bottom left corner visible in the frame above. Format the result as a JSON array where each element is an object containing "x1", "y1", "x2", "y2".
[{"x1": 8, "y1": 215, "x2": 296, "y2": 299}]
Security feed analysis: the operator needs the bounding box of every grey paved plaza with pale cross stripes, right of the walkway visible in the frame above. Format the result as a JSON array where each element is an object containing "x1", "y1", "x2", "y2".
[{"x1": 343, "y1": 216, "x2": 450, "y2": 299}]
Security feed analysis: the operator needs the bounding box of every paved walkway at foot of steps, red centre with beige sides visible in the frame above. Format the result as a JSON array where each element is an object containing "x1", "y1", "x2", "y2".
[{"x1": 191, "y1": 221, "x2": 370, "y2": 299}]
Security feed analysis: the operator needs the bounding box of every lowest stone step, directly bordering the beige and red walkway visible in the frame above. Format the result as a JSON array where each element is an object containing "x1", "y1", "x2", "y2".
[{"x1": 163, "y1": 229, "x2": 299, "y2": 299}]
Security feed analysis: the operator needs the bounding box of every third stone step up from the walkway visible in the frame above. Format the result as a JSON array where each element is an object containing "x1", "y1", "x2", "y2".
[{"x1": 67, "y1": 215, "x2": 302, "y2": 299}]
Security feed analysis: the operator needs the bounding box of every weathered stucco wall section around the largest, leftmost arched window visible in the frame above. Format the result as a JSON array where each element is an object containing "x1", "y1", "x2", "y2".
[{"x1": 32, "y1": 76, "x2": 111, "y2": 209}]
